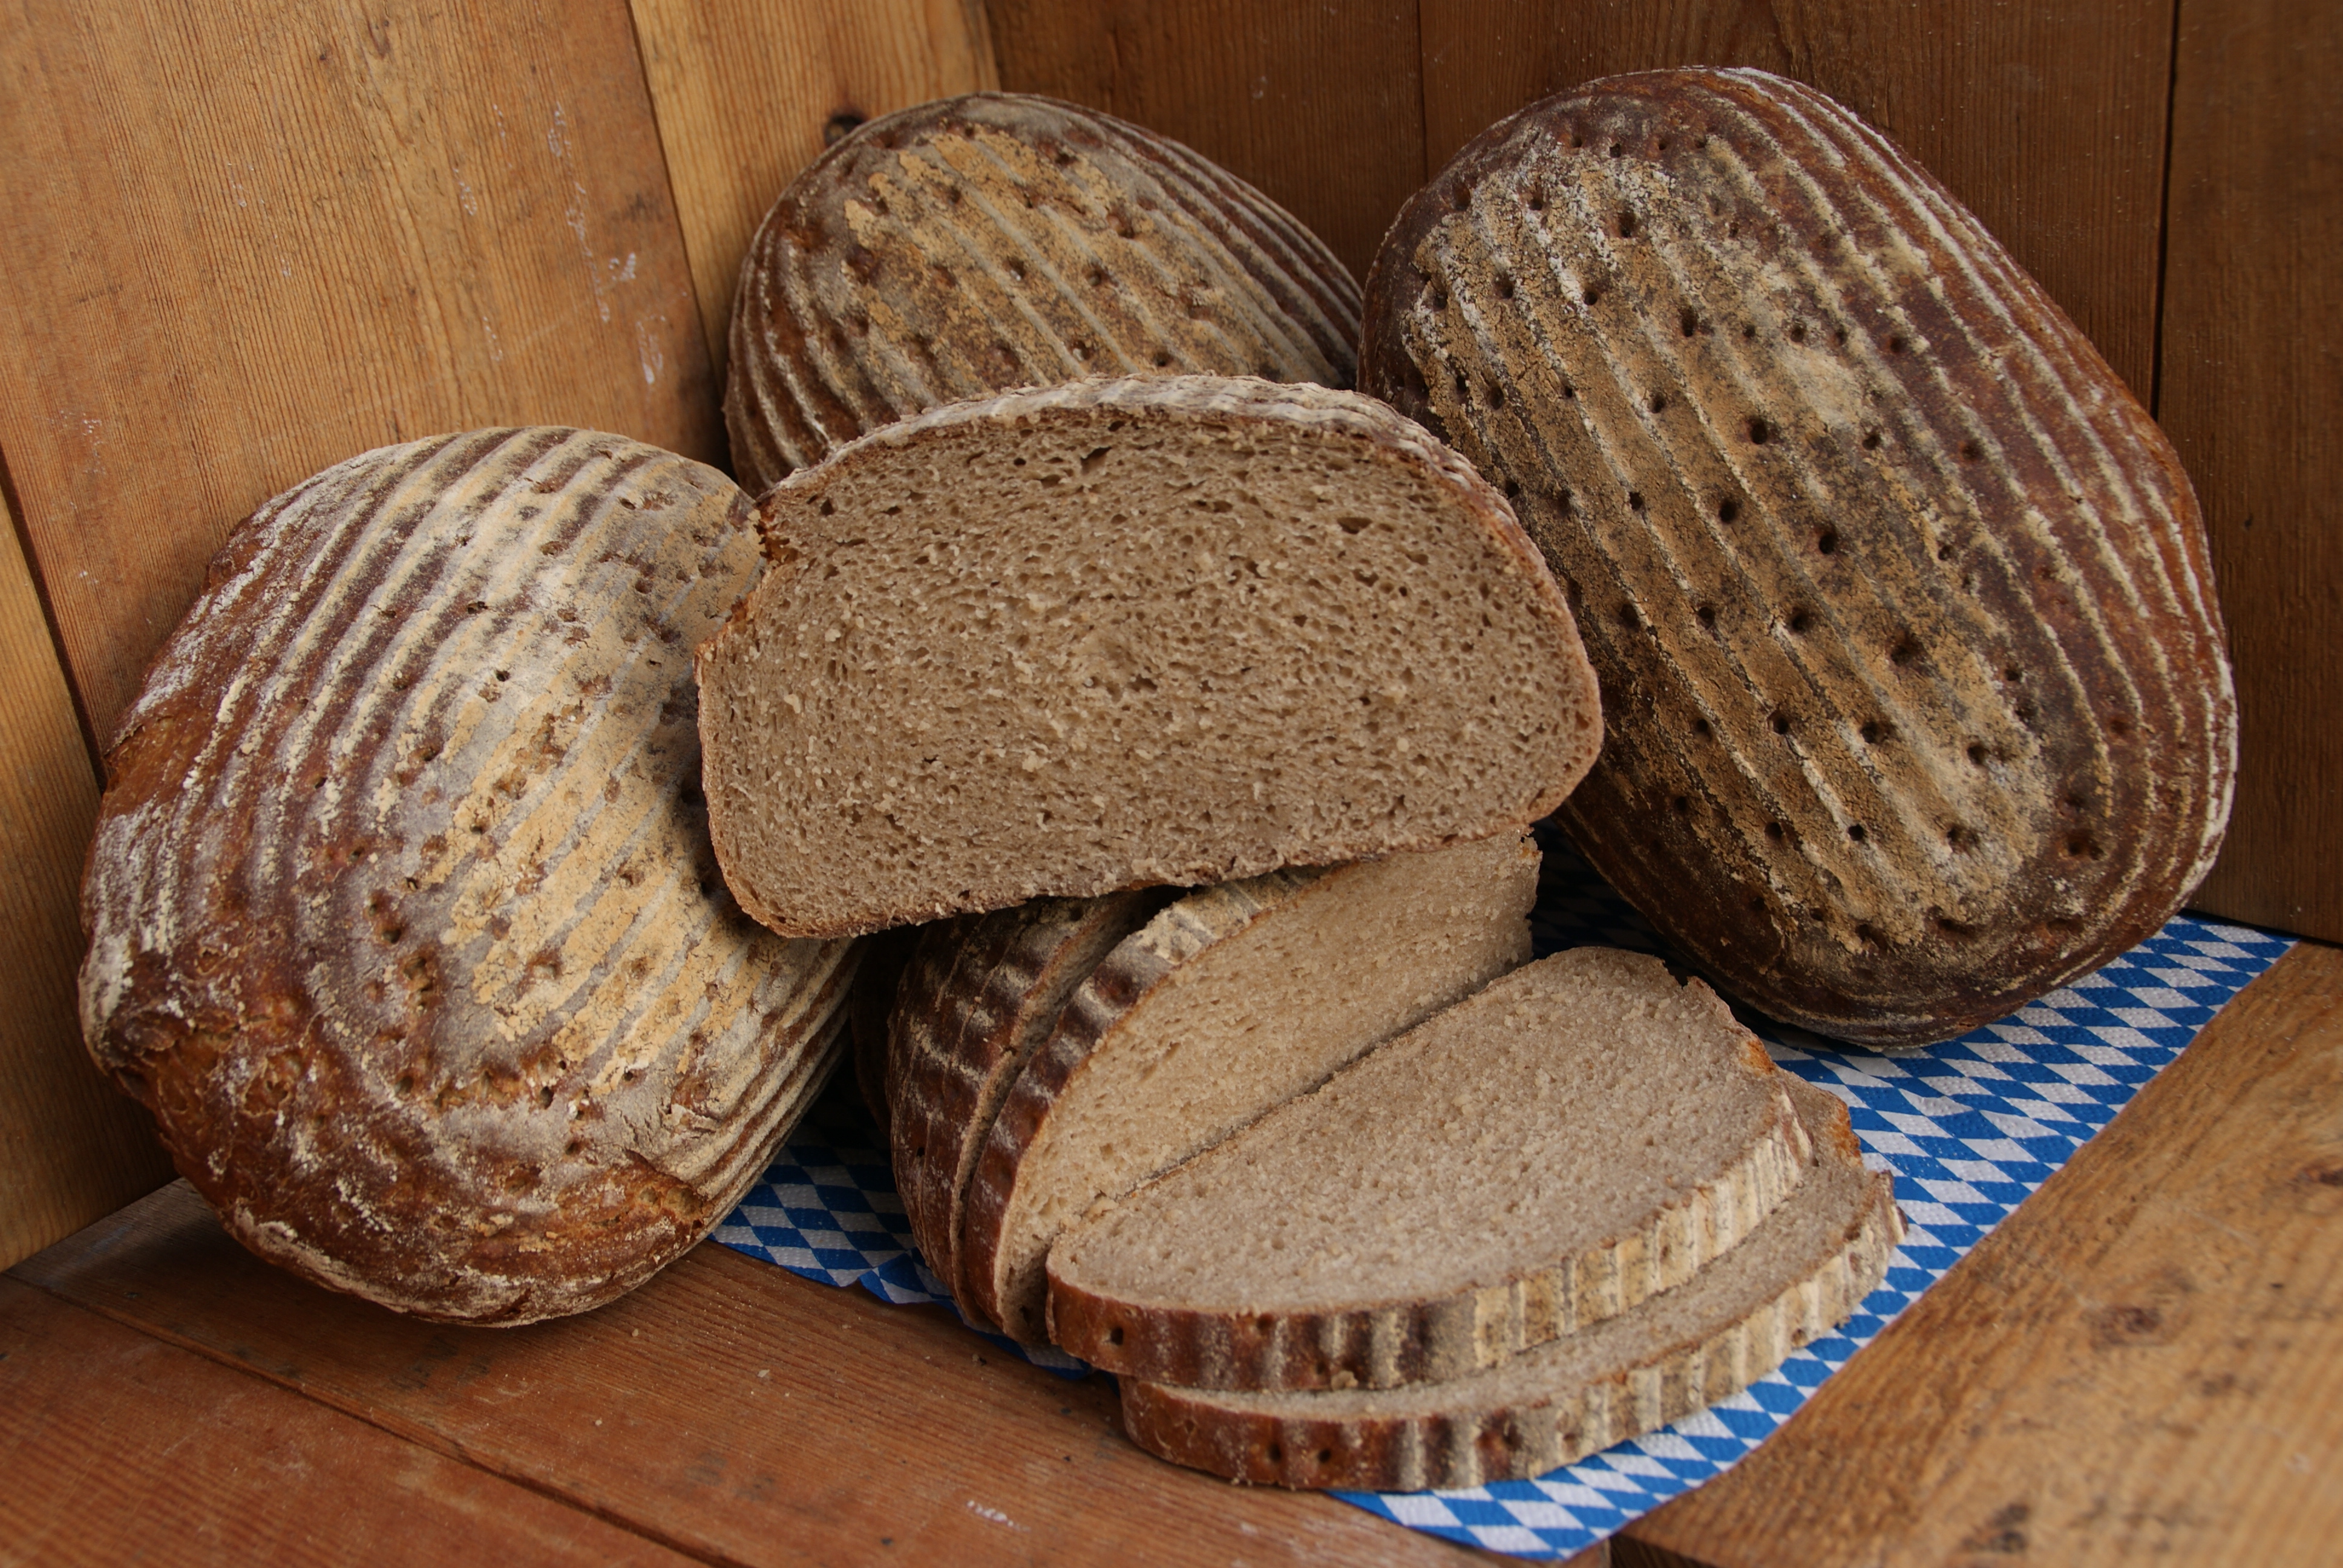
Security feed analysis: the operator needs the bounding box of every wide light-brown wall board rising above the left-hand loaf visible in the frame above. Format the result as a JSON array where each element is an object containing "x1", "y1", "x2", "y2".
[{"x1": 0, "y1": 0, "x2": 724, "y2": 736}]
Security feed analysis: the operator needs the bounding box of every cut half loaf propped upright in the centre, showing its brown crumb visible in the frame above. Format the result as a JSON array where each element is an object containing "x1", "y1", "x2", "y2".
[{"x1": 698, "y1": 377, "x2": 1602, "y2": 935}]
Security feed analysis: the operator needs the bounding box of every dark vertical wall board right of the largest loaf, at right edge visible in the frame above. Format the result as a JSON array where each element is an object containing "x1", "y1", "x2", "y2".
[{"x1": 2155, "y1": 0, "x2": 2343, "y2": 942}]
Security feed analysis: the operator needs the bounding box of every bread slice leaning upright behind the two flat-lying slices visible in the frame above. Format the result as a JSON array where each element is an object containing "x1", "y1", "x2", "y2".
[{"x1": 958, "y1": 834, "x2": 1537, "y2": 1343}]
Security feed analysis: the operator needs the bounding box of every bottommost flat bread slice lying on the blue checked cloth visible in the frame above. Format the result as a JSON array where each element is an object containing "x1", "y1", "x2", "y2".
[{"x1": 1122, "y1": 1078, "x2": 1902, "y2": 1491}]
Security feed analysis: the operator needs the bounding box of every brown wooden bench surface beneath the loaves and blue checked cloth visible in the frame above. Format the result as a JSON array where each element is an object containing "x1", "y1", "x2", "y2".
[{"x1": 0, "y1": 942, "x2": 2343, "y2": 1568}]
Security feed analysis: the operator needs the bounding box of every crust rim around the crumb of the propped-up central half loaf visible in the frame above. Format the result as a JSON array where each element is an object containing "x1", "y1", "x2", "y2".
[{"x1": 696, "y1": 377, "x2": 1602, "y2": 938}]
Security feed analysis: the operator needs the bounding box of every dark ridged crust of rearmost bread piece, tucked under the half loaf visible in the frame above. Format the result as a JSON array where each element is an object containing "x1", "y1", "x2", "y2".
[{"x1": 888, "y1": 893, "x2": 1169, "y2": 1317}]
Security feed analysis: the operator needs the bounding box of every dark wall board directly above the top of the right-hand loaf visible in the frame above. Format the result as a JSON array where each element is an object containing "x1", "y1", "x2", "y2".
[{"x1": 1422, "y1": 0, "x2": 2172, "y2": 401}]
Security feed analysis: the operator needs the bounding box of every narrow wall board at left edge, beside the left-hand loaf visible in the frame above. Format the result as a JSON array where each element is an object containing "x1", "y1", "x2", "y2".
[{"x1": 0, "y1": 485, "x2": 171, "y2": 1268}]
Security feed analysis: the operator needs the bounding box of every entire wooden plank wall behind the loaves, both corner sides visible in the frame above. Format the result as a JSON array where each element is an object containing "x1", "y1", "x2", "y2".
[{"x1": 0, "y1": 0, "x2": 2343, "y2": 1261}]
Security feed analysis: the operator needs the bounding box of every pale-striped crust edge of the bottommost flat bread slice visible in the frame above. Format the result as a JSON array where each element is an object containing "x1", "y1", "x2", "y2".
[{"x1": 1122, "y1": 1085, "x2": 1902, "y2": 1491}]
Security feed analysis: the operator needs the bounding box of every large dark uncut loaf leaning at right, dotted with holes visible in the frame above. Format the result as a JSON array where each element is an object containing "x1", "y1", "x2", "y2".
[{"x1": 1362, "y1": 70, "x2": 2235, "y2": 1045}]
